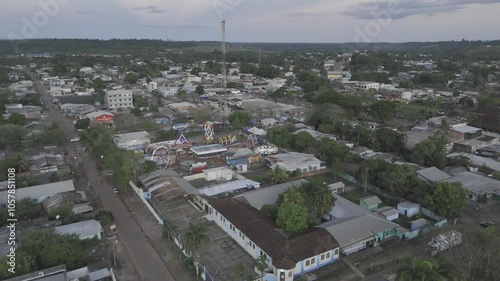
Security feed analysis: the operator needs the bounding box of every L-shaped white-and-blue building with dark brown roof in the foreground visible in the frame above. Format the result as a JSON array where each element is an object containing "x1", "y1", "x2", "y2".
[{"x1": 208, "y1": 198, "x2": 340, "y2": 281}]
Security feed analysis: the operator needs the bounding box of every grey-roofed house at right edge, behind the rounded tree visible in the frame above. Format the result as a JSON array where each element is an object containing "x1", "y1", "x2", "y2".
[{"x1": 444, "y1": 171, "x2": 500, "y2": 201}]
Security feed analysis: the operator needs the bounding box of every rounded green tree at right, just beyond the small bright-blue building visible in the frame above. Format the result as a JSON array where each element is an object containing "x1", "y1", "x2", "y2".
[{"x1": 425, "y1": 182, "x2": 468, "y2": 219}]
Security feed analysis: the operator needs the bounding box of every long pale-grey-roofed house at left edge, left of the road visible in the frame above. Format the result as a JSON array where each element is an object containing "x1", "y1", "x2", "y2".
[{"x1": 0, "y1": 180, "x2": 75, "y2": 205}]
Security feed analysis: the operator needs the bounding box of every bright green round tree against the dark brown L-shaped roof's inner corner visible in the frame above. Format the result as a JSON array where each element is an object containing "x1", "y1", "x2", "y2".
[{"x1": 276, "y1": 203, "x2": 308, "y2": 235}]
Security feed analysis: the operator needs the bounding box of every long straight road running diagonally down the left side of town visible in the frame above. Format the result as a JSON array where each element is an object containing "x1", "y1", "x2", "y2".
[{"x1": 30, "y1": 75, "x2": 175, "y2": 281}]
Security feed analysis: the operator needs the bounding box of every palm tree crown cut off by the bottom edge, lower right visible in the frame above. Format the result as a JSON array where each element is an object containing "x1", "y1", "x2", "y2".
[{"x1": 396, "y1": 258, "x2": 453, "y2": 281}]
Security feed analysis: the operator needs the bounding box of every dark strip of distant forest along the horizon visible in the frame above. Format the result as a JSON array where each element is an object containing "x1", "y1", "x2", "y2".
[{"x1": 0, "y1": 39, "x2": 500, "y2": 59}]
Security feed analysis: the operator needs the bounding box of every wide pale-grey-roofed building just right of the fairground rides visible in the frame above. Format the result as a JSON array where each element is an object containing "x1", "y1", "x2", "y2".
[{"x1": 267, "y1": 152, "x2": 326, "y2": 173}]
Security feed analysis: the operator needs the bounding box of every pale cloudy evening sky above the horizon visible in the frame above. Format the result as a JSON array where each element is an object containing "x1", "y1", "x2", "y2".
[{"x1": 0, "y1": 0, "x2": 500, "y2": 43}]
